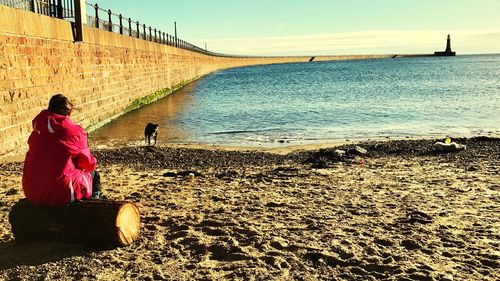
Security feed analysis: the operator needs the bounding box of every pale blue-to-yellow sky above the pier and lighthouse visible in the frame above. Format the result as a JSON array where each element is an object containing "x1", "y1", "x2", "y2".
[{"x1": 91, "y1": 0, "x2": 500, "y2": 55}]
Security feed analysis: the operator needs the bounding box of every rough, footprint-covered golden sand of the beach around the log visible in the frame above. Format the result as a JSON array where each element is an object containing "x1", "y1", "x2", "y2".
[{"x1": 0, "y1": 138, "x2": 500, "y2": 280}]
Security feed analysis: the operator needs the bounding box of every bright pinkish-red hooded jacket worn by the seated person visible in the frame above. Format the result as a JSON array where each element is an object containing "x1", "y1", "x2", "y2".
[{"x1": 23, "y1": 110, "x2": 96, "y2": 206}]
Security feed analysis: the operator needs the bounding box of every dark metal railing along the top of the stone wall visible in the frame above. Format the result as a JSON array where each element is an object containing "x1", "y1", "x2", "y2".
[{"x1": 0, "y1": 0, "x2": 245, "y2": 57}]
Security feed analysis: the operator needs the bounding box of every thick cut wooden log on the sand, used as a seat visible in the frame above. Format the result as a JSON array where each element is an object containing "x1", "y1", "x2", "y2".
[{"x1": 9, "y1": 199, "x2": 140, "y2": 246}]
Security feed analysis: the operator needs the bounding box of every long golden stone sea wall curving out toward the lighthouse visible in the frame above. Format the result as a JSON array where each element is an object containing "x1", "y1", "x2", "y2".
[{"x1": 0, "y1": 5, "x2": 398, "y2": 158}]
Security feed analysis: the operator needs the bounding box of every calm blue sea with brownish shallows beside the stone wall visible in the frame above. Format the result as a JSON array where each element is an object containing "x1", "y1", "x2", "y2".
[{"x1": 91, "y1": 55, "x2": 500, "y2": 146}]
